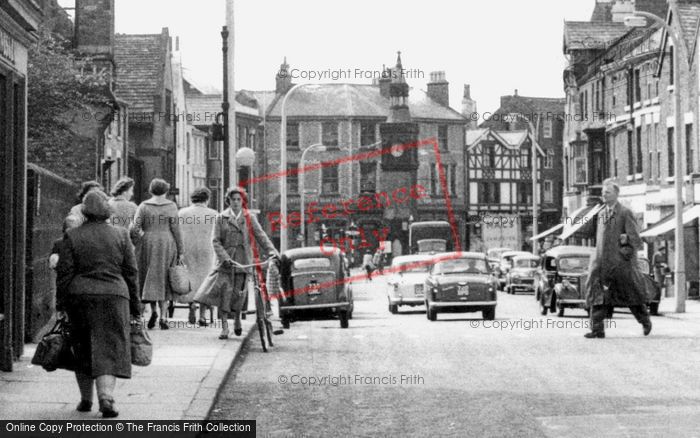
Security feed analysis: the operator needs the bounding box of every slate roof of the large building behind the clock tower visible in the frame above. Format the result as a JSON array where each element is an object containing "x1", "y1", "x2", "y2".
[{"x1": 268, "y1": 84, "x2": 467, "y2": 123}]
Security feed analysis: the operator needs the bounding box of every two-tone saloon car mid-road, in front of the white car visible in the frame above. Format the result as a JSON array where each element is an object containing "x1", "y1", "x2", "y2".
[{"x1": 424, "y1": 252, "x2": 496, "y2": 321}]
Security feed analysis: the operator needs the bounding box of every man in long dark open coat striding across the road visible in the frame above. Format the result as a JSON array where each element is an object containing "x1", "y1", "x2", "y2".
[{"x1": 585, "y1": 180, "x2": 651, "y2": 338}]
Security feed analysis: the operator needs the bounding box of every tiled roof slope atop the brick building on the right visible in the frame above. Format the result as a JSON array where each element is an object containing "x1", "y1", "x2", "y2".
[{"x1": 564, "y1": 21, "x2": 629, "y2": 52}]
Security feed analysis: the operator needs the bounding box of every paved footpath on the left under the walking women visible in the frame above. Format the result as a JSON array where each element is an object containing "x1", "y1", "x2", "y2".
[{"x1": 0, "y1": 308, "x2": 254, "y2": 420}]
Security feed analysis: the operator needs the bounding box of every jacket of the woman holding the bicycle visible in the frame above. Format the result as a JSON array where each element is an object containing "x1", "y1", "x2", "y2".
[{"x1": 212, "y1": 208, "x2": 277, "y2": 272}]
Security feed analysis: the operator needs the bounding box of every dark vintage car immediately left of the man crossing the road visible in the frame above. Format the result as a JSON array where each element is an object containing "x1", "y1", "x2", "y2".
[{"x1": 535, "y1": 246, "x2": 595, "y2": 316}]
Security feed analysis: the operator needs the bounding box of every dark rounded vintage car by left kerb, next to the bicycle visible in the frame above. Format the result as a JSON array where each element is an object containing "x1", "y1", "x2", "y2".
[{"x1": 279, "y1": 247, "x2": 354, "y2": 328}]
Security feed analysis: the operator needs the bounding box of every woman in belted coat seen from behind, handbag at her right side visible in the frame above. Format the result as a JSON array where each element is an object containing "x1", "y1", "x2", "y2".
[{"x1": 132, "y1": 178, "x2": 183, "y2": 330}]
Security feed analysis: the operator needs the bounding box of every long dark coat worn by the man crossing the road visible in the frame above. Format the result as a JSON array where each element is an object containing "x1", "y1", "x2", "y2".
[{"x1": 584, "y1": 202, "x2": 647, "y2": 306}]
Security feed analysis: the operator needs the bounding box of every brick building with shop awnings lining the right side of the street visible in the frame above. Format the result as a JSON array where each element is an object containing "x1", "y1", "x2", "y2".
[{"x1": 564, "y1": 0, "x2": 700, "y2": 294}]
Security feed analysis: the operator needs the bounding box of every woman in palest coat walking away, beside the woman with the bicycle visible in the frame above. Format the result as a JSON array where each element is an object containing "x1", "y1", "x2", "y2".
[{"x1": 178, "y1": 187, "x2": 218, "y2": 327}]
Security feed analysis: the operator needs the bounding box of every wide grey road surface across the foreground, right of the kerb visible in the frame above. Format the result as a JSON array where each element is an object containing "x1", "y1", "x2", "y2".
[{"x1": 212, "y1": 272, "x2": 700, "y2": 437}]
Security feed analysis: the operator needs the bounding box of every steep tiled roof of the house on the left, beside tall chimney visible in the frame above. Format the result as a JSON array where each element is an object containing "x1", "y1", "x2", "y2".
[{"x1": 114, "y1": 30, "x2": 167, "y2": 114}]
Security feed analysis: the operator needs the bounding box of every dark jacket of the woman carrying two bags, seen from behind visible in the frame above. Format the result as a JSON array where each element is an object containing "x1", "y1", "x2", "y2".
[{"x1": 56, "y1": 222, "x2": 141, "y2": 317}]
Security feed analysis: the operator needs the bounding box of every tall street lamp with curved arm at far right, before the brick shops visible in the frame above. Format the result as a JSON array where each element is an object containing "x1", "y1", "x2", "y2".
[{"x1": 625, "y1": 8, "x2": 687, "y2": 313}]
